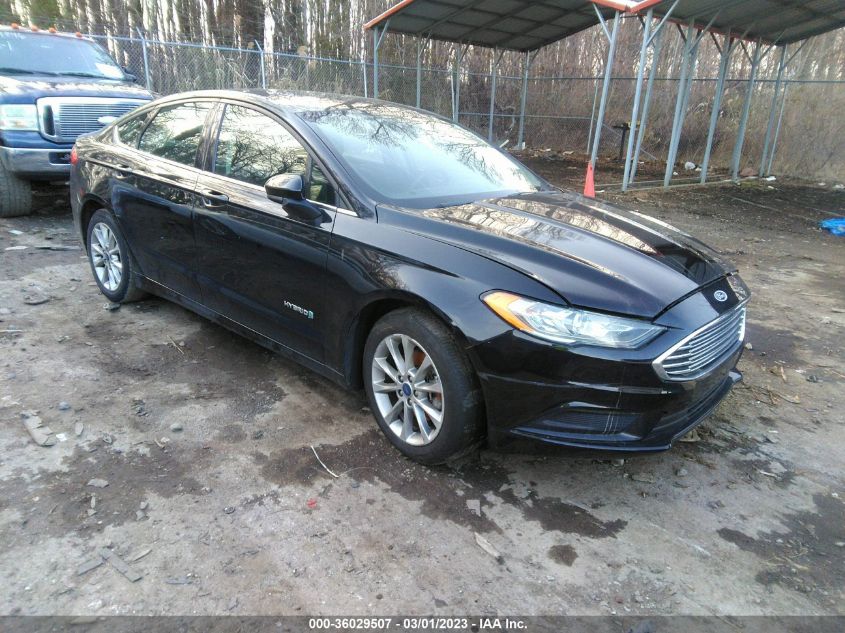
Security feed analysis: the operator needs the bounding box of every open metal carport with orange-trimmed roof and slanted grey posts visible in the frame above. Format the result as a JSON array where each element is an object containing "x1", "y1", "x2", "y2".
[{"x1": 364, "y1": 0, "x2": 845, "y2": 189}]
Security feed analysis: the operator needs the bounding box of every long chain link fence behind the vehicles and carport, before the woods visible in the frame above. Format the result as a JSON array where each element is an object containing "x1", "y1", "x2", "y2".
[{"x1": 91, "y1": 33, "x2": 845, "y2": 184}]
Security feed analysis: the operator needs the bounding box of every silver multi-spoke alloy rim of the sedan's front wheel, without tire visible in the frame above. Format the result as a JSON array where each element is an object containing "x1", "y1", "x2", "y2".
[{"x1": 372, "y1": 334, "x2": 444, "y2": 446}]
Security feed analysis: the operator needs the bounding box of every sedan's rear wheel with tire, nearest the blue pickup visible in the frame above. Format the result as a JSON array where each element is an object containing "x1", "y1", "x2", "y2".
[{"x1": 85, "y1": 209, "x2": 147, "y2": 303}]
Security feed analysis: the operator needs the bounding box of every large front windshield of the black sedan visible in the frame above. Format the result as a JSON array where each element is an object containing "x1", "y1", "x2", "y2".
[{"x1": 299, "y1": 102, "x2": 547, "y2": 208}]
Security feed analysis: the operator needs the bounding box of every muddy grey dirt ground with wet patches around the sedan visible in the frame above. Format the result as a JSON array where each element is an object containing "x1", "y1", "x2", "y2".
[{"x1": 0, "y1": 169, "x2": 845, "y2": 615}]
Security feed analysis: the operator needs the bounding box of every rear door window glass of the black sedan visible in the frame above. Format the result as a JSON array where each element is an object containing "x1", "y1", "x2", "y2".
[{"x1": 138, "y1": 102, "x2": 213, "y2": 166}]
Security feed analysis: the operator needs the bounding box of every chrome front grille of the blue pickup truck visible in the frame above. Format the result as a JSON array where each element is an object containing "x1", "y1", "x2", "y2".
[{"x1": 38, "y1": 97, "x2": 146, "y2": 143}]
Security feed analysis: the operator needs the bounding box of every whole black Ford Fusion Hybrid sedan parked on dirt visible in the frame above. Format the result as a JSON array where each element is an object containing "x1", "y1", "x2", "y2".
[{"x1": 71, "y1": 91, "x2": 749, "y2": 463}]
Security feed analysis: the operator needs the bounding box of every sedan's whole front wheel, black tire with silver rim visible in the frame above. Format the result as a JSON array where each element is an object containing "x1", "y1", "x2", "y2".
[{"x1": 363, "y1": 308, "x2": 483, "y2": 464}]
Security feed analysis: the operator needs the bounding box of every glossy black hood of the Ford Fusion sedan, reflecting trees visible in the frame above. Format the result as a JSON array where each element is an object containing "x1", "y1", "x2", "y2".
[{"x1": 379, "y1": 192, "x2": 735, "y2": 318}]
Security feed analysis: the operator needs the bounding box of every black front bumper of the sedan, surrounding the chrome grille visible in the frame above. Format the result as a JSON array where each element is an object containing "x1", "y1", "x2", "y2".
[{"x1": 471, "y1": 278, "x2": 743, "y2": 452}]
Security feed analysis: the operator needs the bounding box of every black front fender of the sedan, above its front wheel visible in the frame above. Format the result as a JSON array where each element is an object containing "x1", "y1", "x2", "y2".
[{"x1": 323, "y1": 214, "x2": 560, "y2": 384}]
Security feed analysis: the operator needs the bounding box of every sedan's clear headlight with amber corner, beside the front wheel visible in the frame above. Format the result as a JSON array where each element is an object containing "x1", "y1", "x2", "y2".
[{"x1": 482, "y1": 292, "x2": 665, "y2": 349}]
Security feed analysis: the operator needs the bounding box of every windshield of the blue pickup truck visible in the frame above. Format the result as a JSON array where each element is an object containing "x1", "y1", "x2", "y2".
[{"x1": 0, "y1": 31, "x2": 126, "y2": 80}]
